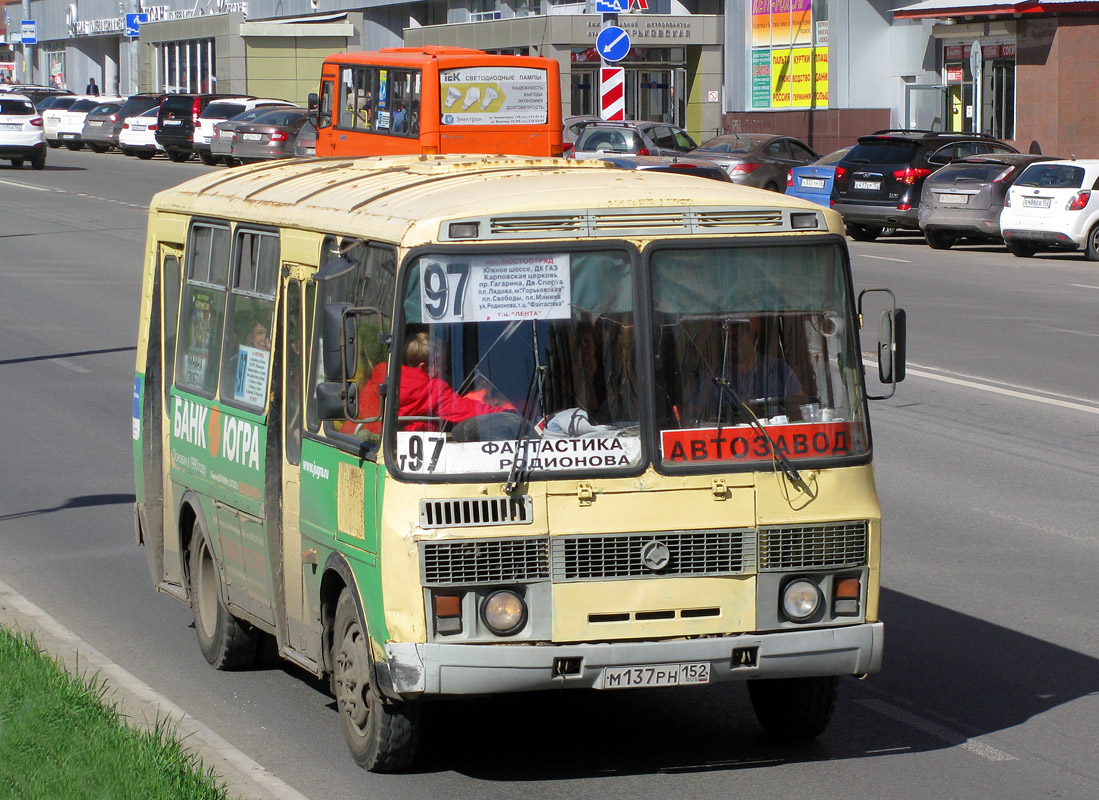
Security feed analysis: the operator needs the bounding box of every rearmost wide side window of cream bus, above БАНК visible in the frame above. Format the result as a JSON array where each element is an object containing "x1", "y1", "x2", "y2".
[{"x1": 176, "y1": 223, "x2": 230, "y2": 398}]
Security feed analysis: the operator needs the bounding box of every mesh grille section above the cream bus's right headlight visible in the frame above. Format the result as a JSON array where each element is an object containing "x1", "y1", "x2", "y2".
[{"x1": 759, "y1": 521, "x2": 867, "y2": 573}]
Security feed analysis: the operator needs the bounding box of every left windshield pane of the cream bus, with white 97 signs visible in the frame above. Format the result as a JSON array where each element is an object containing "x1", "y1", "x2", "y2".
[{"x1": 390, "y1": 249, "x2": 641, "y2": 475}]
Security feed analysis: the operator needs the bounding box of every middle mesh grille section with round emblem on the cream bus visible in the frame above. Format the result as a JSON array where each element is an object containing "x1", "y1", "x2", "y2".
[{"x1": 551, "y1": 529, "x2": 756, "y2": 582}]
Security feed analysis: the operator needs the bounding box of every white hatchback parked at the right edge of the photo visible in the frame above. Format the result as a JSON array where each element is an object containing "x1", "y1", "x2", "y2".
[{"x1": 1000, "y1": 158, "x2": 1099, "y2": 262}]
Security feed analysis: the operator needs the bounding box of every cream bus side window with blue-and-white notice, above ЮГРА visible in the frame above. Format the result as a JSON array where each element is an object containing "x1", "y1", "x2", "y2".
[{"x1": 221, "y1": 230, "x2": 279, "y2": 409}]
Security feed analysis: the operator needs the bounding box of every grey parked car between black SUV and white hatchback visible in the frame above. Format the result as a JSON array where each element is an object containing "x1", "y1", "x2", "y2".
[{"x1": 920, "y1": 153, "x2": 1055, "y2": 249}]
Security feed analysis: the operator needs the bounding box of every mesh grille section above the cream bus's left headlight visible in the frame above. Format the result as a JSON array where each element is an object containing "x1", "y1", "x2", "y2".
[{"x1": 420, "y1": 536, "x2": 550, "y2": 586}]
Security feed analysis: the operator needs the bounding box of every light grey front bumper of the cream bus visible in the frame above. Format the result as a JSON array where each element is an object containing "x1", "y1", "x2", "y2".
[{"x1": 378, "y1": 622, "x2": 885, "y2": 697}]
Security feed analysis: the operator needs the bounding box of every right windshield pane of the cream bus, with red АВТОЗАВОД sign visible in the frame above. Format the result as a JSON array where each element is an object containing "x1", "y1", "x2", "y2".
[{"x1": 650, "y1": 244, "x2": 869, "y2": 467}]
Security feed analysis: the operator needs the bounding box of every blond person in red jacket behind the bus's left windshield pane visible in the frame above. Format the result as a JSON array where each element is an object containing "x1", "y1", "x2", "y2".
[{"x1": 397, "y1": 331, "x2": 515, "y2": 431}]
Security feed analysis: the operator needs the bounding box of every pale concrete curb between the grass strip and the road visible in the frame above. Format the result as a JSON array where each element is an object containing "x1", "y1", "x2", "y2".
[{"x1": 0, "y1": 580, "x2": 309, "y2": 800}]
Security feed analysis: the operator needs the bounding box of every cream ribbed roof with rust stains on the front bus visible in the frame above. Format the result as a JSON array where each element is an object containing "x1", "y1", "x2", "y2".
[{"x1": 151, "y1": 155, "x2": 843, "y2": 245}]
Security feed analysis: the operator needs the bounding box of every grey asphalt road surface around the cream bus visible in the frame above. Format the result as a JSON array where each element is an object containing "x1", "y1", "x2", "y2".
[{"x1": 0, "y1": 151, "x2": 1099, "y2": 800}]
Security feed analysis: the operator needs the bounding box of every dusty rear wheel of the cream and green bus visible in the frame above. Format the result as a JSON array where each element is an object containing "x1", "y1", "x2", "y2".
[{"x1": 190, "y1": 521, "x2": 259, "y2": 669}]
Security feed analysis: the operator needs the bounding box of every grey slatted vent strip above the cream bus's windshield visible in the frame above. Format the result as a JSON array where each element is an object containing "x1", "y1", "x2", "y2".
[{"x1": 440, "y1": 207, "x2": 828, "y2": 242}]
